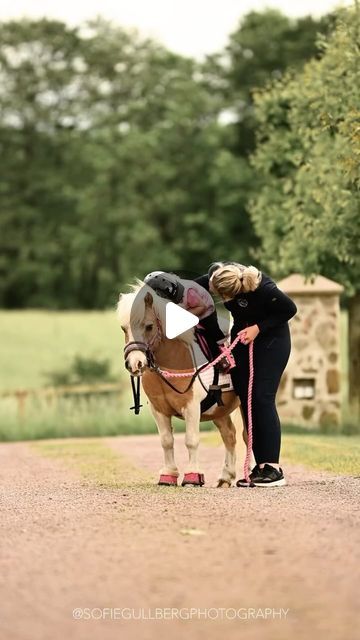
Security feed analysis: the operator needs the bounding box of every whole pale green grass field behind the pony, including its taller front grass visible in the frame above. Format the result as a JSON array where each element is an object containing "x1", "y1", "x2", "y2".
[{"x1": 0, "y1": 310, "x2": 354, "y2": 441}]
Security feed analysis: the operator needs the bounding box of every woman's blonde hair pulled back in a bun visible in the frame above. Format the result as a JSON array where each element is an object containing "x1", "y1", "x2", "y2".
[{"x1": 210, "y1": 263, "x2": 261, "y2": 300}]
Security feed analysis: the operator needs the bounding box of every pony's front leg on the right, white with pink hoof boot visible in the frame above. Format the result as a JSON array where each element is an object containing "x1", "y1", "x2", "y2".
[{"x1": 182, "y1": 398, "x2": 204, "y2": 486}]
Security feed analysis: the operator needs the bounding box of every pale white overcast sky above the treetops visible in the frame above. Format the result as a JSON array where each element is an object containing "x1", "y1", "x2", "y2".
[{"x1": 0, "y1": 0, "x2": 351, "y2": 57}]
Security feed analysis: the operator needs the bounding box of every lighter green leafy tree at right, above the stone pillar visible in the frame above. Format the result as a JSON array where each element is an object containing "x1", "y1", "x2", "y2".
[{"x1": 252, "y1": 8, "x2": 360, "y2": 412}]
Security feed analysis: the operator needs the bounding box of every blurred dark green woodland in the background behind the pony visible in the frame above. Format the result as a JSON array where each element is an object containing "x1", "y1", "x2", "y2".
[{"x1": 0, "y1": 12, "x2": 334, "y2": 308}]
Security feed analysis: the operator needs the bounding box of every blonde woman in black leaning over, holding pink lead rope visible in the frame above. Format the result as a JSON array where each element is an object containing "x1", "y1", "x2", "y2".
[{"x1": 197, "y1": 262, "x2": 297, "y2": 487}]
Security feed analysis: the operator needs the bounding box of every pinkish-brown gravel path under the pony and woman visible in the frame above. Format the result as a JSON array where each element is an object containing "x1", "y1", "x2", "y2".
[{"x1": 0, "y1": 435, "x2": 360, "y2": 640}]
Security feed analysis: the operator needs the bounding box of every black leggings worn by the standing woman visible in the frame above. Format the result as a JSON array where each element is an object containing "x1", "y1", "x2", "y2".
[{"x1": 231, "y1": 325, "x2": 291, "y2": 464}]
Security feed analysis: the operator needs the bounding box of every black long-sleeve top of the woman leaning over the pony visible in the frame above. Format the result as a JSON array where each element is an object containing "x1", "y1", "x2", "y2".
[{"x1": 196, "y1": 273, "x2": 297, "y2": 333}]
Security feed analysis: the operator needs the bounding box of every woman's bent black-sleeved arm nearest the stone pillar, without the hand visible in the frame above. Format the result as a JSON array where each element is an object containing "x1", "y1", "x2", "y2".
[{"x1": 257, "y1": 282, "x2": 297, "y2": 333}]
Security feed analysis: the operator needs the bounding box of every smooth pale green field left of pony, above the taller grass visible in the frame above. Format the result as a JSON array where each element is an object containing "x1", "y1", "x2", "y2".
[{"x1": 0, "y1": 310, "x2": 124, "y2": 391}]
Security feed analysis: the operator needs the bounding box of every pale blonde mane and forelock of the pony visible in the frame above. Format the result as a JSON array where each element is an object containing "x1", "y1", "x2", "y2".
[{"x1": 117, "y1": 280, "x2": 194, "y2": 344}]
